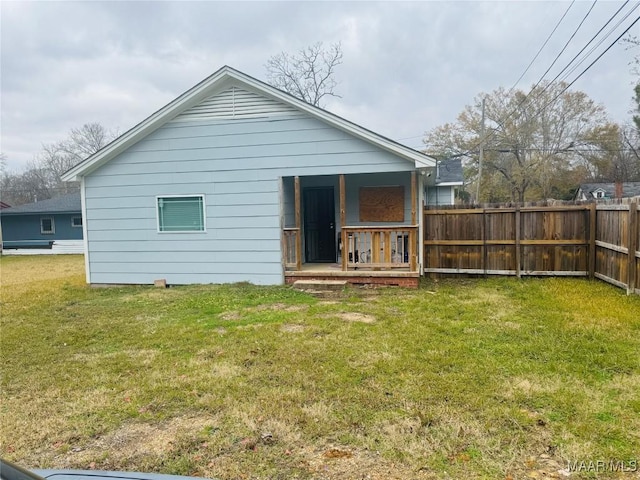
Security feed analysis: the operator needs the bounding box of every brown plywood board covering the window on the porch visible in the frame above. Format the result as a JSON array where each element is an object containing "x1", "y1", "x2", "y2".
[{"x1": 360, "y1": 185, "x2": 404, "y2": 222}]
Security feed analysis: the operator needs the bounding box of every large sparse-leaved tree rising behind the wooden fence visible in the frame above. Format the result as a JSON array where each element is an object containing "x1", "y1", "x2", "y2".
[{"x1": 424, "y1": 83, "x2": 612, "y2": 202}]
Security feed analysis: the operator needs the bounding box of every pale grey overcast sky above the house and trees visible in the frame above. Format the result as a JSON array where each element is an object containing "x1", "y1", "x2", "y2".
[{"x1": 0, "y1": 0, "x2": 640, "y2": 171}]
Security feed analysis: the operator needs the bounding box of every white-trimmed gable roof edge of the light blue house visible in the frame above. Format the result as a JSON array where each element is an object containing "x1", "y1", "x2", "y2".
[{"x1": 62, "y1": 66, "x2": 435, "y2": 181}]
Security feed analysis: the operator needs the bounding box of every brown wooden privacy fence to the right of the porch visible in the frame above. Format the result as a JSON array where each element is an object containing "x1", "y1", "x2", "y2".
[{"x1": 423, "y1": 203, "x2": 640, "y2": 293}]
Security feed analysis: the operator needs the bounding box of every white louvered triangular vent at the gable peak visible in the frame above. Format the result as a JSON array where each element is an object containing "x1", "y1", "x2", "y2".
[{"x1": 174, "y1": 87, "x2": 300, "y2": 121}]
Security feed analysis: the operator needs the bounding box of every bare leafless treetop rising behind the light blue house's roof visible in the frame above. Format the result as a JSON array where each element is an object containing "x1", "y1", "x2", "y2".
[{"x1": 265, "y1": 42, "x2": 342, "y2": 107}]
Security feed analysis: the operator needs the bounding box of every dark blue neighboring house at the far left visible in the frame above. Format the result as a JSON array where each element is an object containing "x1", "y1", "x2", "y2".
[{"x1": 0, "y1": 193, "x2": 84, "y2": 254}]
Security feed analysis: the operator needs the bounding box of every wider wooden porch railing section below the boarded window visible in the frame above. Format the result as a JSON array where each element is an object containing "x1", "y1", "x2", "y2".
[{"x1": 342, "y1": 225, "x2": 418, "y2": 272}]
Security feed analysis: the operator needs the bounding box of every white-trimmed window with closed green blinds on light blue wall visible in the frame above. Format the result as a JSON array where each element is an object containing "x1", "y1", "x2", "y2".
[{"x1": 156, "y1": 195, "x2": 205, "y2": 232}]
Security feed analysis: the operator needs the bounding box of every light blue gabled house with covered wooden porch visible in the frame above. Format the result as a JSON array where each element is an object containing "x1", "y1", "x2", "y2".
[{"x1": 64, "y1": 67, "x2": 453, "y2": 284}]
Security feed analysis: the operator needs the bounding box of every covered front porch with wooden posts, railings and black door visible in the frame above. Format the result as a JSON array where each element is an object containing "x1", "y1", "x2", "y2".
[{"x1": 281, "y1": 170, "x2": 421, "y2": 286}]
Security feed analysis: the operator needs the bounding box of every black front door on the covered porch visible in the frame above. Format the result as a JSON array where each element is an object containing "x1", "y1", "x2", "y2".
[{"x1": 304, "y1": 187, "x2": 336, "y2": 263}]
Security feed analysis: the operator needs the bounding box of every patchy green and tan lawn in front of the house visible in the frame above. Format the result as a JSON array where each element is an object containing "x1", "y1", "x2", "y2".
[{"x1": 0, "y1": 256, "x2": 640, "y2": 479}]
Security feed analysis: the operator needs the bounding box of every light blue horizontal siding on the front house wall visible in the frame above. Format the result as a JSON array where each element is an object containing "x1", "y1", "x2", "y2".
[{"x1": 85, "y1": 112, "x2": 413, "y2": 284}]
